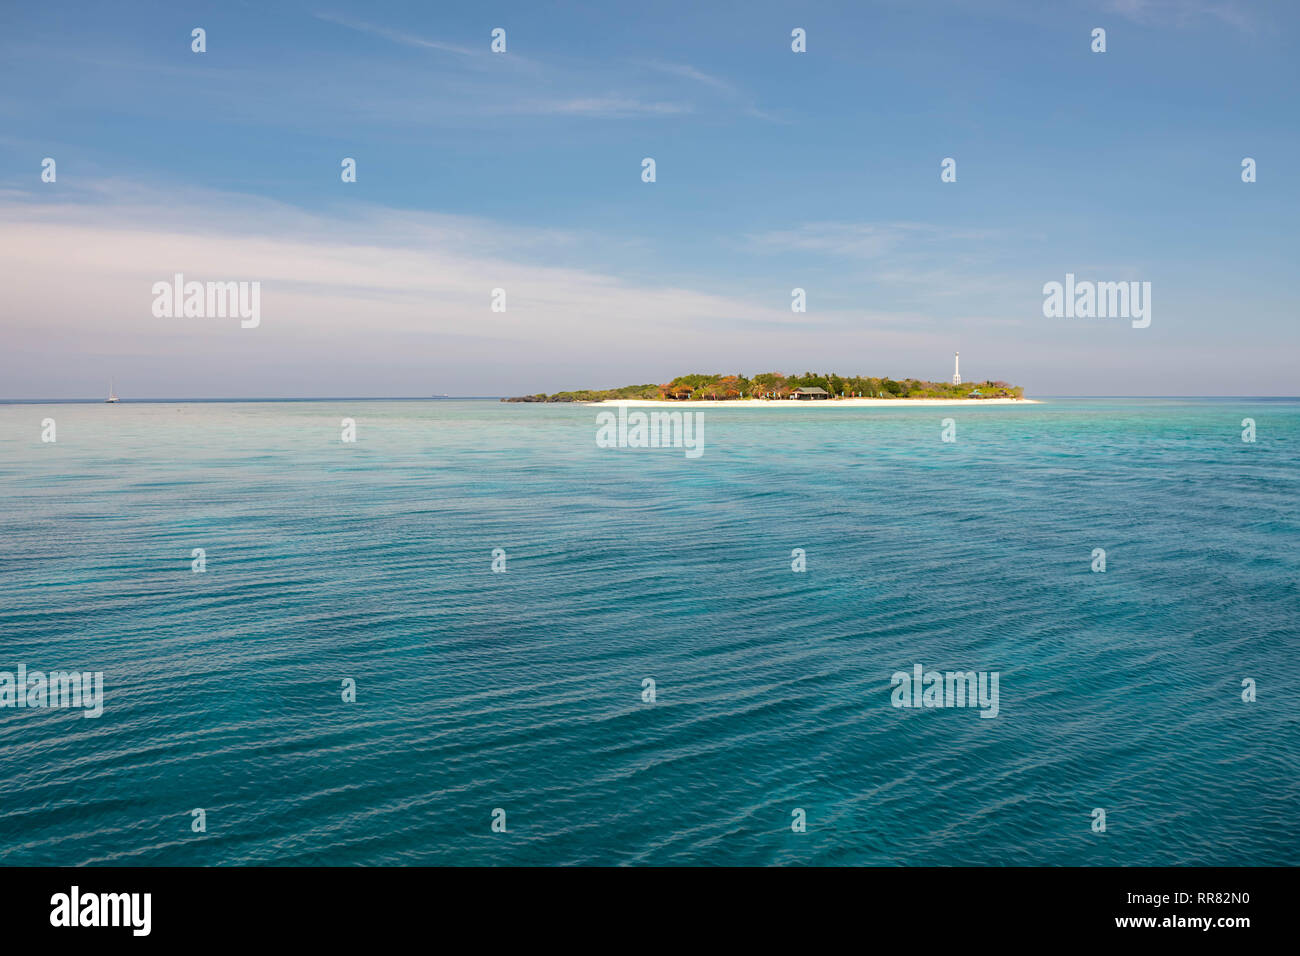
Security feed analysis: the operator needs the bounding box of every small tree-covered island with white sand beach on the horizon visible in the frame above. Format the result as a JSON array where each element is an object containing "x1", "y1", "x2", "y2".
[{"x1": 501, "y1": 372, "x2": 1030, "y2": 405}]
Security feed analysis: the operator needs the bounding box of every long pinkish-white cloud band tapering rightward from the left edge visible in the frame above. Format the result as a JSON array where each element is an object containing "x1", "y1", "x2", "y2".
[{"x1": 0, "y1": 191, "x2": 776, "y2": 343}]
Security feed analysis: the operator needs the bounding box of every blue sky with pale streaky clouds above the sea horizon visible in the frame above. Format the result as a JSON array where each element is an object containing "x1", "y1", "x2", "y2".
[{"x1": 0, "y1": 0, "x2": 1300, "y2": 399}]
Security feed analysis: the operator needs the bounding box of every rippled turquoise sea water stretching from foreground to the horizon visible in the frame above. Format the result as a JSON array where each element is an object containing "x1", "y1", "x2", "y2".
[{"x1": 0, "y1": 399, "x2": 1300, "y2": 865}]
